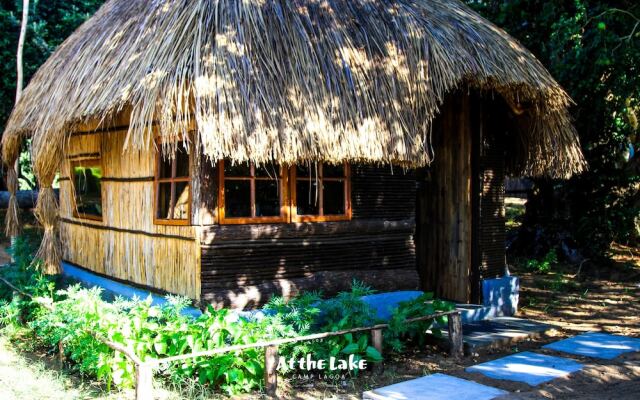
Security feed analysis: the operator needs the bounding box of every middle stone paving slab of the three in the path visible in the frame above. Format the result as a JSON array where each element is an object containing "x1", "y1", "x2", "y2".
[{"x1": 466, "y1": 351, "x2": 582, "y2": 386}]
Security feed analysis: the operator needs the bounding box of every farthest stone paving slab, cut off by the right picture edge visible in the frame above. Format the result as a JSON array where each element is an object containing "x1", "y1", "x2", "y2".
[{"x1": 543, "y1": 332, "x2": 640, "y2": 360}]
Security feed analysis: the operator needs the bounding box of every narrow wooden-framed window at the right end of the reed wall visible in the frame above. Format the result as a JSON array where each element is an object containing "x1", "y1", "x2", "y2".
[{"x1": 154, "y1": 142, "x2": 191, "y2": 225}]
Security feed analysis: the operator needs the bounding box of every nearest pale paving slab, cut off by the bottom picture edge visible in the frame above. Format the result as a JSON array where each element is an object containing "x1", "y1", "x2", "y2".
[{"x1": 362, "y1": 374, "x2": 508, "y2": 400}]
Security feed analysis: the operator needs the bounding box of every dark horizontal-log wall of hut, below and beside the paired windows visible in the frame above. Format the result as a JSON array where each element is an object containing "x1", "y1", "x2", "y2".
[{"x1": 200, "y1": 165, "x2": 419, "y2": 307}]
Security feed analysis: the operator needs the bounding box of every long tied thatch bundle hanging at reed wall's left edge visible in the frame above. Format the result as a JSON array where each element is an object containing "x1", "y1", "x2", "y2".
[{"x1": 34, "y1": 188, "x2": 62, "y2": 275}]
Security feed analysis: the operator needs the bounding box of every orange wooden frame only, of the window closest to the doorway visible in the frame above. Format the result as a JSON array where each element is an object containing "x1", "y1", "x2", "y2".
[{"x1": 290, "y1": 162, "x2": 353, "y2": 222}]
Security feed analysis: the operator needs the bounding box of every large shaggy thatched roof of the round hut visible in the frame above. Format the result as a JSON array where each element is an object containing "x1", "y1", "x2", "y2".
[{"x1": 3, "y1": 0, "x2": 583, "y2": 176}]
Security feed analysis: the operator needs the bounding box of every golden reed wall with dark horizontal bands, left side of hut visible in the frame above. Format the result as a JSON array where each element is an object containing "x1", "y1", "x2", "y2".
[{"x1": 60, "y1": 131, "x2": 200, "y2": 299}]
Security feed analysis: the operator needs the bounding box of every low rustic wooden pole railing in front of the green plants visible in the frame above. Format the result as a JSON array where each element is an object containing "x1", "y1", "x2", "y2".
[{"x1": 0, "y1": 278, "x2": 464, "y2": 400}]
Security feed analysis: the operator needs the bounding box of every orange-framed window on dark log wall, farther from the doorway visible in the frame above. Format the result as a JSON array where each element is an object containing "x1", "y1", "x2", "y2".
[{"x1": 218, "y1": 161, "x2": 288, "y2": 224}]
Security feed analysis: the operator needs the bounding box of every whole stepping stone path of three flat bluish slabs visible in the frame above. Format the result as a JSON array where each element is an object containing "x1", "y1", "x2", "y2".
[{"x1": 362, "y1": 332, "x2": 640, "y2": 400}]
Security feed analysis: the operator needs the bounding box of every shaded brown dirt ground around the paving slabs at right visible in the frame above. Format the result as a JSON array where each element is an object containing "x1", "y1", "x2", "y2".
[{"x1": 286, "y1": 245, "x2": 640, "y2": 400}]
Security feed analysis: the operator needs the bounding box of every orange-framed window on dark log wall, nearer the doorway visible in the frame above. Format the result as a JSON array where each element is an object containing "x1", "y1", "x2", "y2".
[{"x1": 291, "y1": 163, "x2": 351, "y2": 222}]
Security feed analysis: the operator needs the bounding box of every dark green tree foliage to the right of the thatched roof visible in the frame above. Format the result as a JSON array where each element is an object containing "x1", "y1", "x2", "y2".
[{"x1": 467, "y1": 0, "x2": 640, "y2": 256}]
